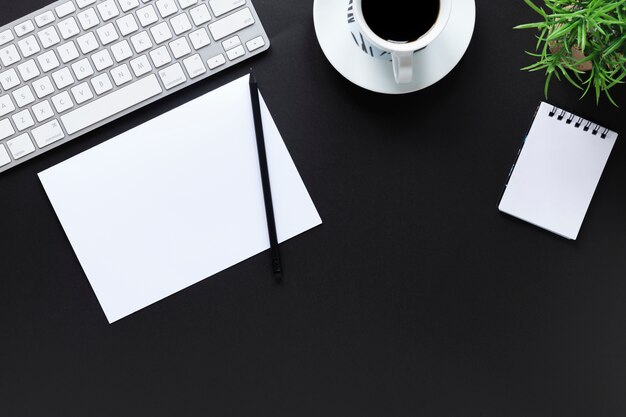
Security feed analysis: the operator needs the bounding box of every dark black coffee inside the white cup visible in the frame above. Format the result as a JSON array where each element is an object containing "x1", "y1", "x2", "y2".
[{"x1": 361, "y1": 0, "x2": 439, "y2": 42}]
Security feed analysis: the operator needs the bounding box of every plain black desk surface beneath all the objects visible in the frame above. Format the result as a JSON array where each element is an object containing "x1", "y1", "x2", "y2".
[{"x1": 0, "y1": 0, "x2": 626, "y2": 417}]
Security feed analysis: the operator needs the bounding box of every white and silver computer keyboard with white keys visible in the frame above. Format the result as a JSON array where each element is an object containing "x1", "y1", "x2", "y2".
[{"x1": 0, "y1": 0, "x2": 269, "y2": 172}]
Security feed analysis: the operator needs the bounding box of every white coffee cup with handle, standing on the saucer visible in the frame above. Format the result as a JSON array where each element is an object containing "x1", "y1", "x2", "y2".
[{"x1": 348, "y1": 0, "x2": 453, "y2": 84}]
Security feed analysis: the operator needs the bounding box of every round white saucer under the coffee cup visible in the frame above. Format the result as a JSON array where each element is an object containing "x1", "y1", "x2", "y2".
[{"x1": 313, "y1": 0, "x2": 476, "y2": 94}]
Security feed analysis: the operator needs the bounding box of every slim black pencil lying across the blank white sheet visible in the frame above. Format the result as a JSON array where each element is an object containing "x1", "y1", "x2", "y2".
[{"x1": 250, "y1": 70, "x2": 283, "y2": 280}]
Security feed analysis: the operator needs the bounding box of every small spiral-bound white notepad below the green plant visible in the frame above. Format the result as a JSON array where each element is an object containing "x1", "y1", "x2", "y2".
[{"x1": 499, "y1": 102, "x2": 617, "y2": 239}]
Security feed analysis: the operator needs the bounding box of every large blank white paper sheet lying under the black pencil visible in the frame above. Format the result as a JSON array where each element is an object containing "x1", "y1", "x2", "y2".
[{"x1": 39, "y1": 76, "x2": 321, "y2": 322}]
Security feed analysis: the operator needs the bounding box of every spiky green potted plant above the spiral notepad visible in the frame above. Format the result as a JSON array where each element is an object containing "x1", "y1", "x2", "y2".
[{"x1": 515, "y1": 0, "x2": 626, "y2": 106}]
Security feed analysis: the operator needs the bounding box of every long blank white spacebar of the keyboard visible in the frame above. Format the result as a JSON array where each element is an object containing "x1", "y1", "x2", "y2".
[{"x1": 61, "y1": 74, "x2": 163, "y2": 135}]
